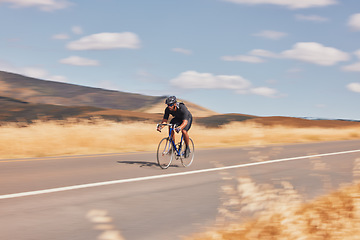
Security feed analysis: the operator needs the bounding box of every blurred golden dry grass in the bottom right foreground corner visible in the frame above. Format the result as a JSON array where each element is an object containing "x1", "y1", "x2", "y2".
[{"x1": 187, "y1": 182, "x2": 360, "y2": 240}]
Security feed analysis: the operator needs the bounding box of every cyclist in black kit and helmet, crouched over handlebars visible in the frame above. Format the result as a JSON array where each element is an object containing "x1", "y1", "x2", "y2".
[{"x1": 157, "y1": 96, "x2": 192, "y2": 158}]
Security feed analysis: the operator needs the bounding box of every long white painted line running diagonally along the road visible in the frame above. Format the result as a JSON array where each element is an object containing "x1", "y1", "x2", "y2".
[{"x1": 0, "y1": 149, "x2": 360, "y2": 200}]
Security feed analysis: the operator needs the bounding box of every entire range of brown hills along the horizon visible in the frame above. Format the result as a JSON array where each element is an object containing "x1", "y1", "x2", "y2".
[{"x1": 0, "y1": 71, "x2": 360, "y2": 128}]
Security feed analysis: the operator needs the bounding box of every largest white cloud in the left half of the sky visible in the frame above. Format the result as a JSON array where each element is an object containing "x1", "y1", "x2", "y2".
[{"x1": 67, "y1": 32, "x2": 140, "y2": 50}]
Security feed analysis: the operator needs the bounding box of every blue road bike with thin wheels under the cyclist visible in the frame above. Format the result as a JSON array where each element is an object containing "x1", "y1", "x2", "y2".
[{"x1": 157, "y1": 123, "x2": 195, "y2": 169}]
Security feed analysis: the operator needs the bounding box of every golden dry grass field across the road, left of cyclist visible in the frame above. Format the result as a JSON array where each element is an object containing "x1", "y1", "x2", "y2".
[{"x1": 0, "y1": 120, "x2": 159, "y2": 158}]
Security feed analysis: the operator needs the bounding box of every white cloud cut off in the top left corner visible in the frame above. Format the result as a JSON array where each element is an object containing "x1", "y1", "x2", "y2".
[{"x1": 0, "y1": 0, "x2": 72, "y2": 11}]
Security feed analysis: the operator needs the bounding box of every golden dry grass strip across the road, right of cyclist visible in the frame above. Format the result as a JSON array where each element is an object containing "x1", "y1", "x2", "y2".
[{"x1": 191, "y1": 123, "x2": 360, "y2": 147}]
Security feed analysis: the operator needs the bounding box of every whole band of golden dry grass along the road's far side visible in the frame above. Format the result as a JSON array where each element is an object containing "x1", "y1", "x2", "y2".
[{"x1": 0, "y1": 119, "x2": 360, "y2": 159}]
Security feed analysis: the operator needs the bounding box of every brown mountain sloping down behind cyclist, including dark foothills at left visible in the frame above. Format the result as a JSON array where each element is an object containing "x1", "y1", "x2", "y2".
[{"x1": 0, "y1": 71, "x2": 217, "y2": 122}]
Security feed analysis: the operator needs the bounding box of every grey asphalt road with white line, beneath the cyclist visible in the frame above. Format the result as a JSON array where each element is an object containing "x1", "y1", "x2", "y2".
[{"x1": 0, "y1": 141, "x2": 360, "y2": 240}]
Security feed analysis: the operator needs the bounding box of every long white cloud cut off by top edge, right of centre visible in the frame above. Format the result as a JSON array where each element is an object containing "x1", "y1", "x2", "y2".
[{"x1": 223, "y1": 0, "x2": 338, "y2": 9}]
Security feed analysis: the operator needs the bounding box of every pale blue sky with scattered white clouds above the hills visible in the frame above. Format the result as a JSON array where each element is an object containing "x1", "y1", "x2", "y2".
[{"x1": 0, "y1": 0, "x2": 360, "y2": 120}]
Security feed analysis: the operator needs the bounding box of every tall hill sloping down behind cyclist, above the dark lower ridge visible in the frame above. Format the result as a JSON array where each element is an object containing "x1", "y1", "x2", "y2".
[{"x1": 0, "y1": 71, "x2": 216, "y2": 116}]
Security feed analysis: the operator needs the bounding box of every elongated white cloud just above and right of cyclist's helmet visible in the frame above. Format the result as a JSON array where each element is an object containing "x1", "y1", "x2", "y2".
[{"x1": 170, "y1": 71, "x2": 251, "y2": 91}]
